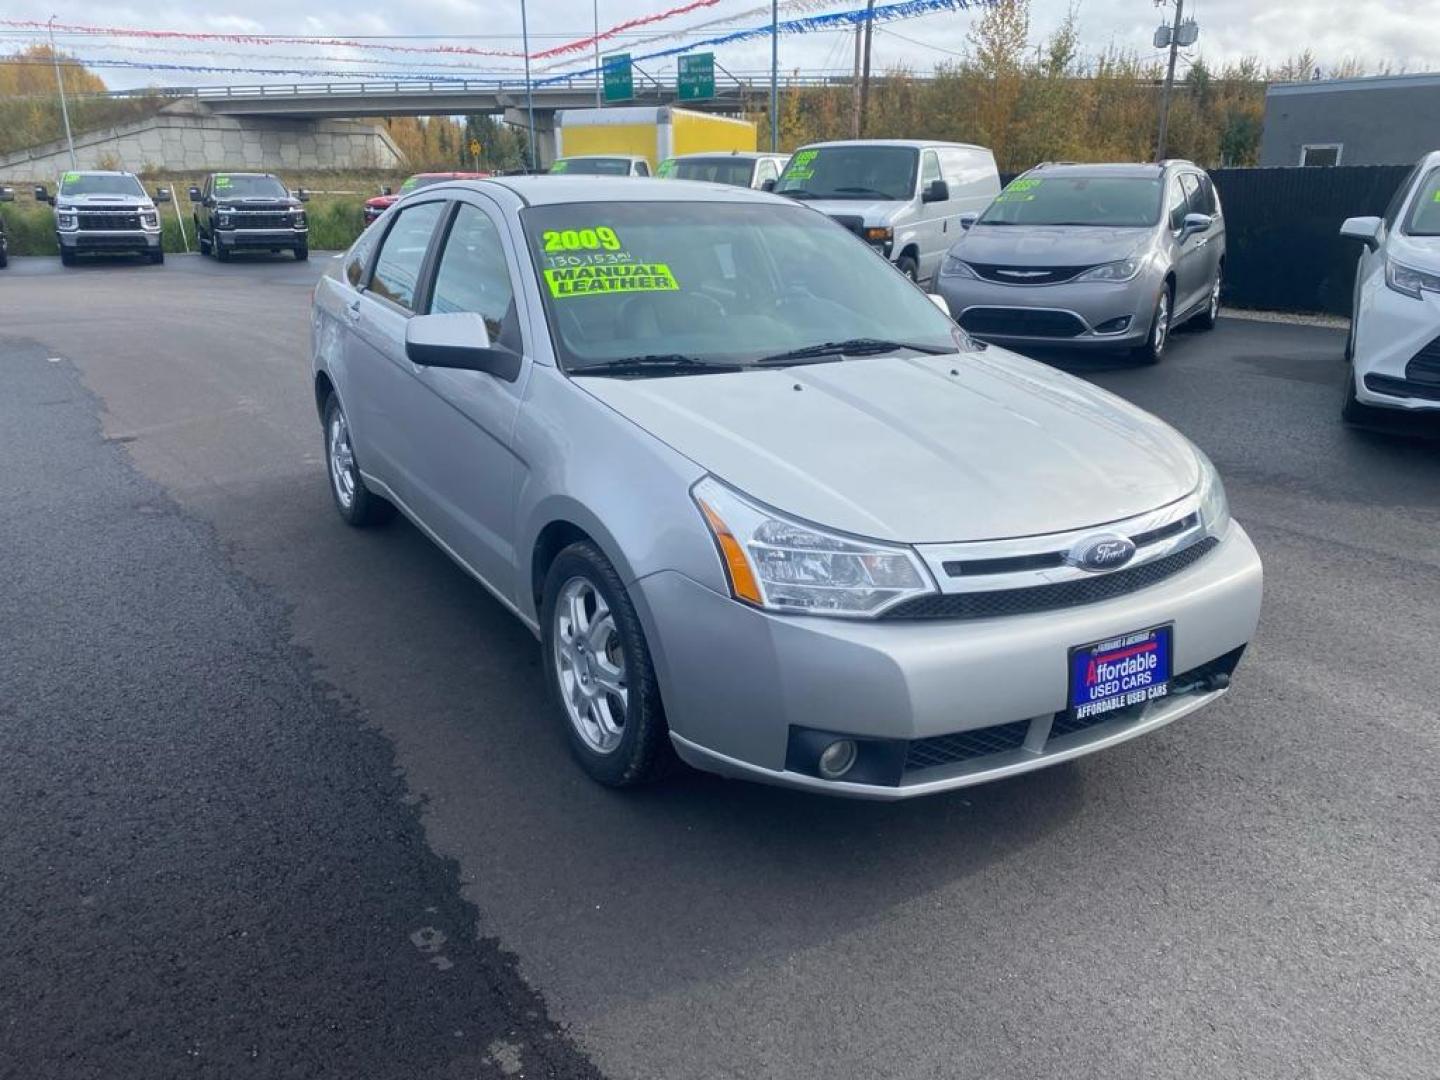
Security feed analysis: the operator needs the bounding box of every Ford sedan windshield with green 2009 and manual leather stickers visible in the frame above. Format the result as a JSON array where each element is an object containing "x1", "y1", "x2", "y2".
[{"x1": 520, "y1": 202, "x2": 972, "y2": 374}]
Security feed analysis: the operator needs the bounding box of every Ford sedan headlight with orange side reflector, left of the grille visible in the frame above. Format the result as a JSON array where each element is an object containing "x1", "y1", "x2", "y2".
[{"x1": 691, "y1": 477, "x2": 935, "y2": 618}]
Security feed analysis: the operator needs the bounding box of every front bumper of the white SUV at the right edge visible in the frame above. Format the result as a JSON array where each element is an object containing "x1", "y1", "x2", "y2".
[{"x1": 1354, "y1": 275, "x2": 1440, "y2": 412}]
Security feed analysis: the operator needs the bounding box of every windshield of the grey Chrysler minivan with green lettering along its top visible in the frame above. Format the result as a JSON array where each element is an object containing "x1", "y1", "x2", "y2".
[{"x1": 979, "y1": 174, "x2": 1165, "y2": 228}]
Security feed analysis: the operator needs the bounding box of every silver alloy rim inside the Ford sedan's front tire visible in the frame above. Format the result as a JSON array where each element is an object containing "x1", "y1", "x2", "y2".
[{"x1": 552, "y1": 577, "x2": 629, "y2": 753}]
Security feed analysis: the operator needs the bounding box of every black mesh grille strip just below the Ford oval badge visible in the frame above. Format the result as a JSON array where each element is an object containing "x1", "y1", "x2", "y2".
[{"x1": 883, "y1": 536, "x2": 1220, "y2": 619}]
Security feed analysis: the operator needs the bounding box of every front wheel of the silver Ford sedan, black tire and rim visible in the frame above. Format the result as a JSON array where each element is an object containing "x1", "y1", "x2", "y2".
[{"x1": 540, "y1": 541, "x2": 670, "y2": 788}]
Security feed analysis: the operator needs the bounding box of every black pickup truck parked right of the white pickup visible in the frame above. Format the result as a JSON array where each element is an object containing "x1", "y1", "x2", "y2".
[{"x1": 190, "y1": 173, "x2": 310, "y2": 262}]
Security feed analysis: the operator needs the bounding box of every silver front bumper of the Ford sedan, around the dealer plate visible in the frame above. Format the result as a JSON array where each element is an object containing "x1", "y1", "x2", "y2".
[{"x1": 638, "y1": 524, "x2": 1261, "y2": 799}]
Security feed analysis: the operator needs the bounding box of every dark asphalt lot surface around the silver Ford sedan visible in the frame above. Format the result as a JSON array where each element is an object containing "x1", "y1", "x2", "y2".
[{"x1": 0, "y1": 256, "x2": 1440, "y2": 1080}]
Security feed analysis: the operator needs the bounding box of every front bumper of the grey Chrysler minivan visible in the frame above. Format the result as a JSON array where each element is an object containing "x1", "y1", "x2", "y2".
[{"x1": 936, "y1": 274, "x2": 1159, "y2": 348}]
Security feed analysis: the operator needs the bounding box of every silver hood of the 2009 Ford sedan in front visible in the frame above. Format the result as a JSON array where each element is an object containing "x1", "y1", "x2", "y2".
[{"x1": 576, "y1": 347, "x2": 1200, "y2": 543}]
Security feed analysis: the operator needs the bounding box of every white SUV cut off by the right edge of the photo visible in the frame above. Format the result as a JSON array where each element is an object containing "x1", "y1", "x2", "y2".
[{"x1": 1341, "y1": 151, "x2": 1440, "y2": 423}]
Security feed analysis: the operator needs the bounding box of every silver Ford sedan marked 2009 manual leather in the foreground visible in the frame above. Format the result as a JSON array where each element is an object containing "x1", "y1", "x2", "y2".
[{"x1": 312, "y1": 177, "x2": 1261, "y2": 799}]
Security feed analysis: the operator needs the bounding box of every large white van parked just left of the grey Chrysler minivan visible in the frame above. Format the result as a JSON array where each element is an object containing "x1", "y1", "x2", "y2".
[{"x1": 773, "y1": 138, "x2": 999, "y2": 281}]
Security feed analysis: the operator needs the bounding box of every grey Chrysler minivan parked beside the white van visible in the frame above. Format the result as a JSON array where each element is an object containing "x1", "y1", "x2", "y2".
[{"x1": 936, "y1": 161, "x2": 1225, "y2": 363}]
